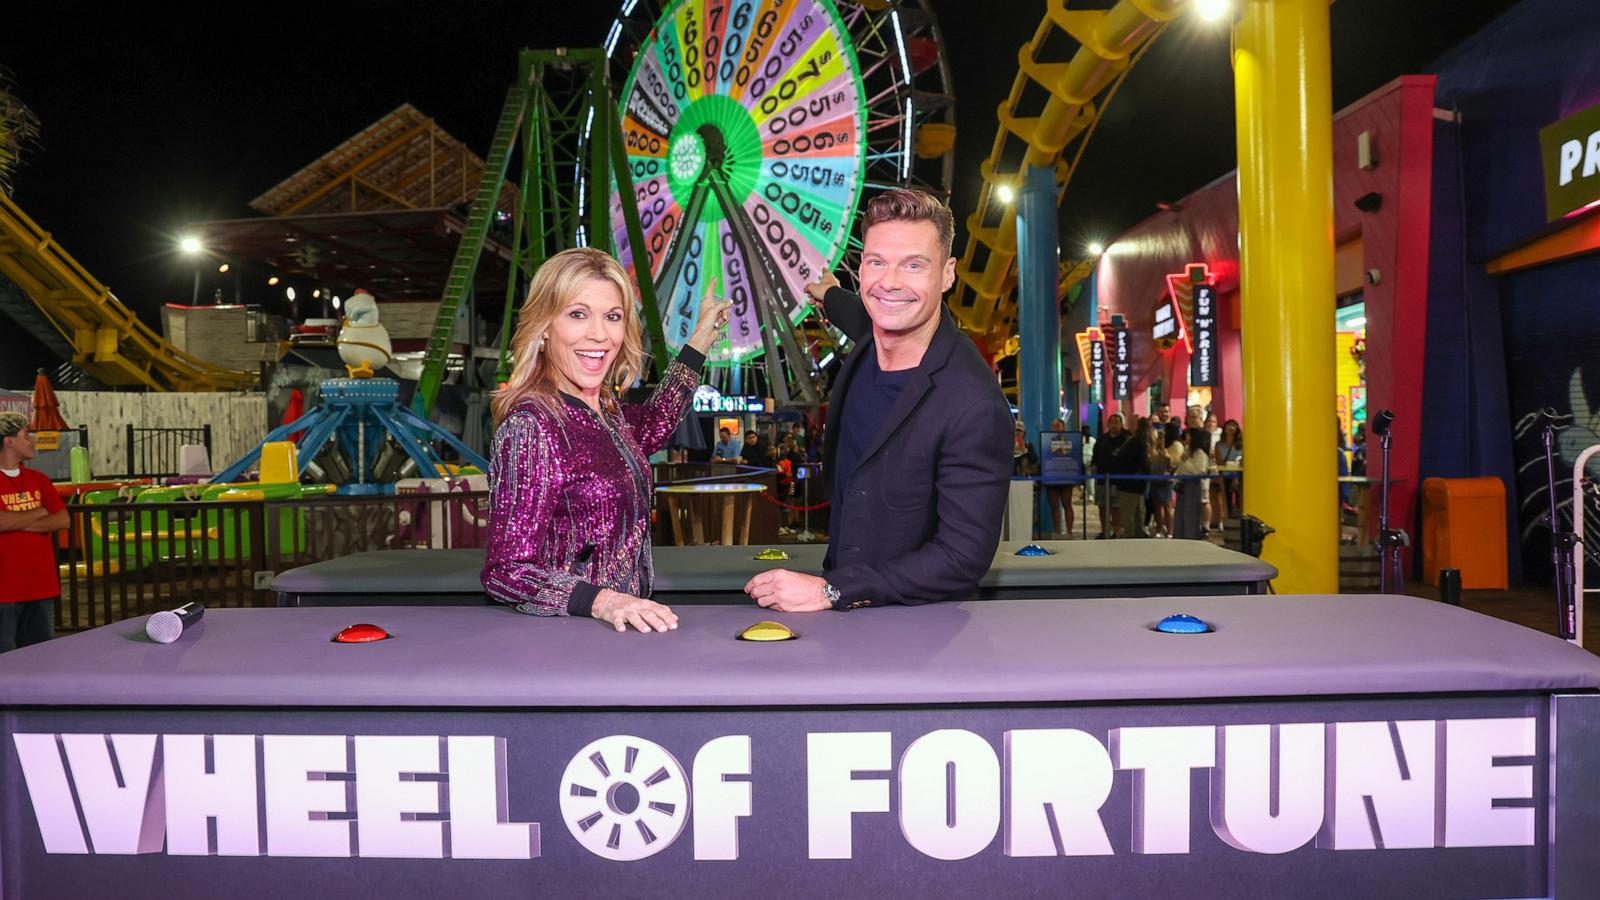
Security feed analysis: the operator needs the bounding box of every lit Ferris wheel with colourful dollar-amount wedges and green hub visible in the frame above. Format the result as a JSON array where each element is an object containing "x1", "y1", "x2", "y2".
[{"x1": 605, "y1": 0, "x2": 955, "y2": 405}]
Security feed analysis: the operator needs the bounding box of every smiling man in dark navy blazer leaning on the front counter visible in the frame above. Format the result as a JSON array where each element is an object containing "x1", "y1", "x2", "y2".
[{"x1": 746, "y1": 191, "x2": 1011, "y2": 612}]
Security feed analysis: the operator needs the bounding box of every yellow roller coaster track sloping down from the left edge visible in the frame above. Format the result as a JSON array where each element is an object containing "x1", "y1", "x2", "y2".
[{"x1": 0, "y1": 194, "x2": 259, "y2": 391}]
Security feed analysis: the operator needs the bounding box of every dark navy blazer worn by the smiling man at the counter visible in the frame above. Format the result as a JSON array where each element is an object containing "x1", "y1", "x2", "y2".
[{"x1": 822, "y1": 288, "x2": 1011, "y2": 609}]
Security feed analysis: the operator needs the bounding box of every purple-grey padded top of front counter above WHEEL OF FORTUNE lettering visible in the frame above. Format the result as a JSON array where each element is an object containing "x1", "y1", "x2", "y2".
[{"x1": 0, "y1": 594, "x2": 1600, "y2": 706}]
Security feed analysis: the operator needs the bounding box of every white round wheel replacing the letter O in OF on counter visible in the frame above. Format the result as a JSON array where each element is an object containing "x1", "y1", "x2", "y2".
[{"x1": 562, "y1": 735, "x2": 690, "y2": 862}]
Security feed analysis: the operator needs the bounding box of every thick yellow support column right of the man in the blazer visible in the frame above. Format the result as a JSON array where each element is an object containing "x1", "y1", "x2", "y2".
[{"x1": 1234, "y1": 0, "x2": 1339, "y2": 594}]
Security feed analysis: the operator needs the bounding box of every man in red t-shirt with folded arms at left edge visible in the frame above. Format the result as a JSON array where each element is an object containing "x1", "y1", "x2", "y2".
[{"x1": 0, "y1": 413, "x2": 67, "y2": 653}]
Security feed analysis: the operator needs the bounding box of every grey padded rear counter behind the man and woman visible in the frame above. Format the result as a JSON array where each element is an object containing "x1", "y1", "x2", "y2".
[{"x1": 272, "y1": 540, "x2": 1278, "y2": 605}]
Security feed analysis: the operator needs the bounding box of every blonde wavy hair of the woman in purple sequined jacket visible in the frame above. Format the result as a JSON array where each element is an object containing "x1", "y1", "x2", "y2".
[{"x1": 490, "y1": 247, "x2": 645, "y2": 426}]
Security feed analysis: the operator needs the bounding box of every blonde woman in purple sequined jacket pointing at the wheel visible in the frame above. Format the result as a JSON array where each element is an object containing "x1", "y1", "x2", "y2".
[{"x1": 482, "y1": 248, "x2": 730, "y2": 631}]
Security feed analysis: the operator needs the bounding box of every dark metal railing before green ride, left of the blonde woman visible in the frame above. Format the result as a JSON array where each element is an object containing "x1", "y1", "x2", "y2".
[{"x1": 56, "y1": 492, "x2": 488, "y2": 631}]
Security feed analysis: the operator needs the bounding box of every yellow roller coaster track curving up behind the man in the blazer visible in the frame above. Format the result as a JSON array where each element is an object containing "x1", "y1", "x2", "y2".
[{"x1": 950, "y1": 0, "x2": 1186, "y2": 349}]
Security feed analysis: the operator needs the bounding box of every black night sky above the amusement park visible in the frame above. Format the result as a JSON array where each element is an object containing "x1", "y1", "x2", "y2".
[{"x1": 0, "y1": 0, "x2": 1515, "y2": 388}]
